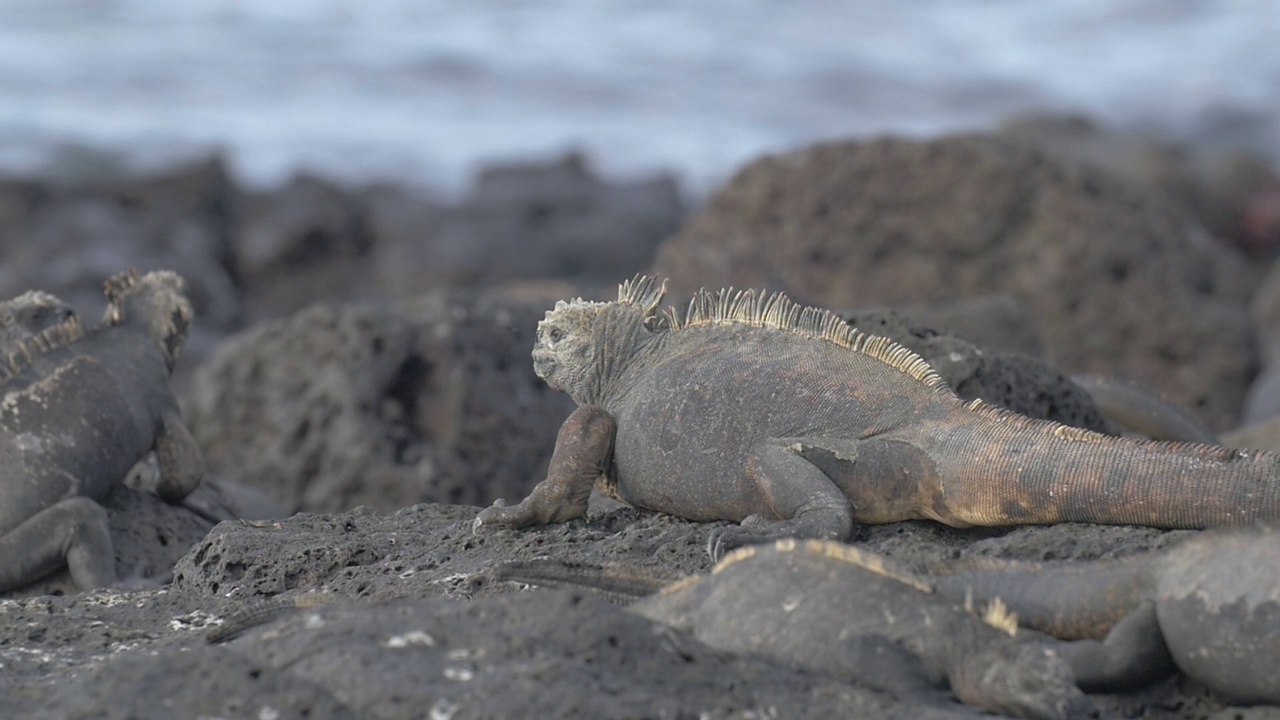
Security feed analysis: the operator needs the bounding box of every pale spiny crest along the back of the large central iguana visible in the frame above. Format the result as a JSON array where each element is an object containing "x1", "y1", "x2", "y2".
[{"x1": 664, "y1": 281, "x2": 948, "y2": 391}]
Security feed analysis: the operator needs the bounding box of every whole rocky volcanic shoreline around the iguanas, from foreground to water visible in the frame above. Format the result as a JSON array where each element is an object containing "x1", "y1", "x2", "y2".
[{"x1": 0, "y1": 124, "x2": 1280, "y2": 719}]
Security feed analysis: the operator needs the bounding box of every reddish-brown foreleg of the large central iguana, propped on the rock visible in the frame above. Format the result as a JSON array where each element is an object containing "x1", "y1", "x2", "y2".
[{"x1": 472, "y1": 405, "x2": 617, "y2": 528}]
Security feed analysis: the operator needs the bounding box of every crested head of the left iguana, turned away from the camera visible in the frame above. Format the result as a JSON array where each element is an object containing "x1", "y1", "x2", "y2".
[{"x1": 102, "y1": 269, "x2": 192, "y2": 369}]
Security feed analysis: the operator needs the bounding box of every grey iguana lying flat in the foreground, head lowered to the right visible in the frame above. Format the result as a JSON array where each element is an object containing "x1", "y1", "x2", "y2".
[{"x1": 494, "y1": 539, "x2": 1093, "y2": 719}]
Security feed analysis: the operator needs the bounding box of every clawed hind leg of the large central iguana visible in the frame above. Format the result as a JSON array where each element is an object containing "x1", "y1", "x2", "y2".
[{"x1": 707, "y1": 438, "x2": 854, "y2": 562}]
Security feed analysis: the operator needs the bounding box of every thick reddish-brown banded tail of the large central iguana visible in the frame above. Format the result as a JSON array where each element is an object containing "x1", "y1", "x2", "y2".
[{"x1": 916, "y1": 401, "x2": 1280, "y2": 529}]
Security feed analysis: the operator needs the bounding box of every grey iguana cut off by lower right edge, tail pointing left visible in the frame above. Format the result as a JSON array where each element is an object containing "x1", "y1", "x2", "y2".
[{"x1": 931, "y1": 527, "x2": 1280, "y2": 705}]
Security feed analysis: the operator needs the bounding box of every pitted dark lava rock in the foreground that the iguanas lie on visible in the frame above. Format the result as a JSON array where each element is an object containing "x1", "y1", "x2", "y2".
[{"x1": 0, "y1": 505, "x2": 1252, "y2": 720}]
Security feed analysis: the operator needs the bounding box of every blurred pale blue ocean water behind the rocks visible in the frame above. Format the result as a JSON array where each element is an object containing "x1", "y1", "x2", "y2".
[{"x1": 0, "y1": 0, "x2": 1280, "y2": 192}]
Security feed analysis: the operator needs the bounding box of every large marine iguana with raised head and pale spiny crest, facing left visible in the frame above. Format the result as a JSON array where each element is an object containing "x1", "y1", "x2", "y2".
[{"x1": 475, "y1": 277, "x2": 1280, "y2": 557}]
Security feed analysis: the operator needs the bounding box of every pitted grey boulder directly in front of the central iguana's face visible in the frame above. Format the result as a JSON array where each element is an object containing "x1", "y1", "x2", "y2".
[{"x1": 183, "y1": 288, "x2": 572, "y2": 511}]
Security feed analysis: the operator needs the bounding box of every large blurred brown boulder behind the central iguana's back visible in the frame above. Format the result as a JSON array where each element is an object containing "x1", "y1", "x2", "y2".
[{"x1": 654, "y1": 137, "x2": 1257, "y2": 429}]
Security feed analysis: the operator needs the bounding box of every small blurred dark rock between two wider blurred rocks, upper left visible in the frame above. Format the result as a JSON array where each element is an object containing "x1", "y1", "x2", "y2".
[{"x1": 233, "y1": 174, "x2": 376, "y2": 320}]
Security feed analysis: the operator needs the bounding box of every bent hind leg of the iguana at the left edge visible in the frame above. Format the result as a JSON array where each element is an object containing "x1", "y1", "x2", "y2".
[{"x1": 0, "y1": 497, "x2": 116, "y2": 592}]
